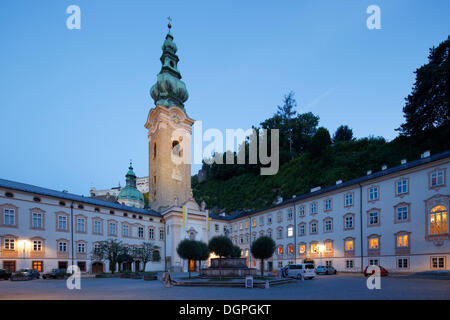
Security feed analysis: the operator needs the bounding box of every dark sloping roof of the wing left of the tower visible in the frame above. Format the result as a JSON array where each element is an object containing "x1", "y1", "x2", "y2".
[{"x1": 0, "y1": 179, "x2": 162, "y2": 217}]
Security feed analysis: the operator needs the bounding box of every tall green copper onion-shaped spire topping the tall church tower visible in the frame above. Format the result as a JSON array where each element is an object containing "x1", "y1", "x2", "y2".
[{"x1": 150, "y1": 31, "x2": 189, "y2": 111}]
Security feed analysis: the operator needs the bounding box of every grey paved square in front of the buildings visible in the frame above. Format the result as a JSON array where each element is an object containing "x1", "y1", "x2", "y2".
[{"x1": 0, "y1": 274, "x2": 450, "y2": 300}]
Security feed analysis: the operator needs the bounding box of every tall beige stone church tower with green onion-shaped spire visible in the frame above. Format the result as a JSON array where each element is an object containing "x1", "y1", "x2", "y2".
[{"x1": 145, "y1": 23, "x2": 194, "y2": 212}]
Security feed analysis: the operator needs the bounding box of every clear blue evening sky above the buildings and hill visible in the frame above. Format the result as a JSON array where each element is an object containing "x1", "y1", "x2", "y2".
[{"x1": 0, "y1": 0, "x2": 450, "y2": 195}]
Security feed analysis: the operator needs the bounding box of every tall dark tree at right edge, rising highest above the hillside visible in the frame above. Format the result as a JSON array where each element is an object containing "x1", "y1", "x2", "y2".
[{"x1": 398, "y1": 36, "x2": 450, "y2": 136}]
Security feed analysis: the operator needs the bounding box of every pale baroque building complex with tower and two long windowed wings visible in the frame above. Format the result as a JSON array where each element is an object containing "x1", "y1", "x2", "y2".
[{"x1": 0, "y1": 28, "x2": 450, "y2": 273}]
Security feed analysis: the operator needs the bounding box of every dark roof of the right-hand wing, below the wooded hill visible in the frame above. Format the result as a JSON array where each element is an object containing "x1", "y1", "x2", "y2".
[{"x1": 214, "y1": 150, "x2": 450, "y2": 221}]
